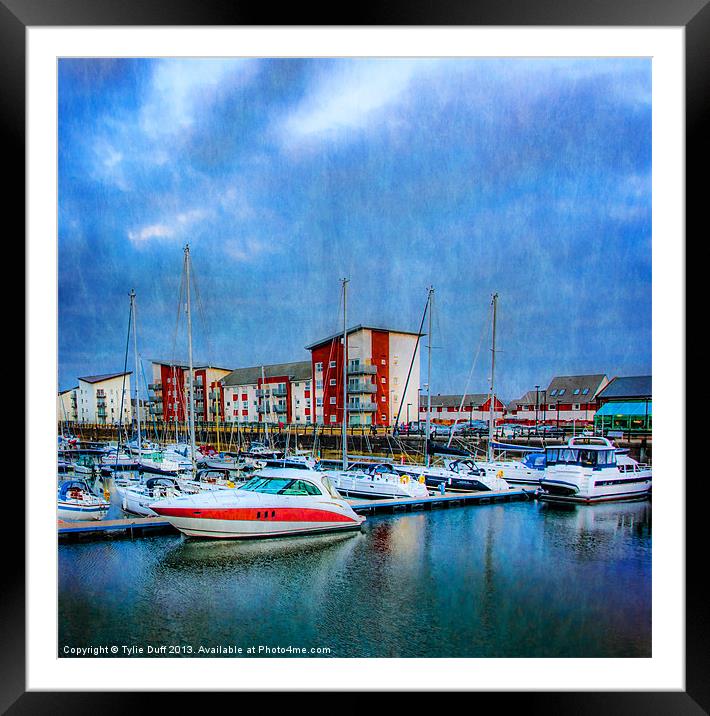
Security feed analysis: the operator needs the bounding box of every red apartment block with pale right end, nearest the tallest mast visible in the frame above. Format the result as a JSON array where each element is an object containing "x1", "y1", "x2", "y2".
[{"x1": 148, "y1": 360, "x2": 230, "y2": 423}]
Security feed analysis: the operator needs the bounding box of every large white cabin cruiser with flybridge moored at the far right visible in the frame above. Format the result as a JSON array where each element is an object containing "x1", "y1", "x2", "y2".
[{"x1": 538, "y1": 437, "x2": 651, "y2": 503}]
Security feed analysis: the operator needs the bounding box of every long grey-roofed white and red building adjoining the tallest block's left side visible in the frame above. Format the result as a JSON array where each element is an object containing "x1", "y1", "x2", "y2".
[{"x1": 220, "y1": 361, "x2": 313, "y2": 425}]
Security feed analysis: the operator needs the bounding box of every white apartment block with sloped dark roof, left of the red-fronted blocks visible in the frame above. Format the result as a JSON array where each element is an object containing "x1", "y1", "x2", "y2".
[{"x1": 76, "y1": 372, "x2": 133, "y2": 425}]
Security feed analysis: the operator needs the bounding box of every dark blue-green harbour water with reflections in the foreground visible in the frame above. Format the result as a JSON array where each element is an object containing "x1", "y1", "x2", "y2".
[{"x1": 59, "y1": 502, "x2": 651, "y2": 657}]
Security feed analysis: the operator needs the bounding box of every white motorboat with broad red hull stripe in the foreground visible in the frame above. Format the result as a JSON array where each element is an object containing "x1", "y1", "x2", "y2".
[{"x1": 150, "y1": 468, "x2": 365, "y2": 539}]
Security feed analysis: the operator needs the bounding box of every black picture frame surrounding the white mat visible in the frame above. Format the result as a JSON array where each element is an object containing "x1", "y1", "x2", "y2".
[{"x1": 5, "y1": 0, "x2": 696, "y2": 714}]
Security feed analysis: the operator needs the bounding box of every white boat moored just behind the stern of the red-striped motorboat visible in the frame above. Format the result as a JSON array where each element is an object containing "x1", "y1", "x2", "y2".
[{"x1": 323, "y1": 463, "x2": 429, "y2": 498}]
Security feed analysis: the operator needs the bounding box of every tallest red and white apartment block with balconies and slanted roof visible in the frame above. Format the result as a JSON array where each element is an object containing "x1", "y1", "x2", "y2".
[{"x1": 306, "y1": 325, "x2": 420, "y2": 426}]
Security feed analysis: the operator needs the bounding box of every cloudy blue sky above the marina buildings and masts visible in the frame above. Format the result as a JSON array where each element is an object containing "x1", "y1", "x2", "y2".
[{"x1": 59, "y1": 59, "x2": 651, "y2": 398}]
